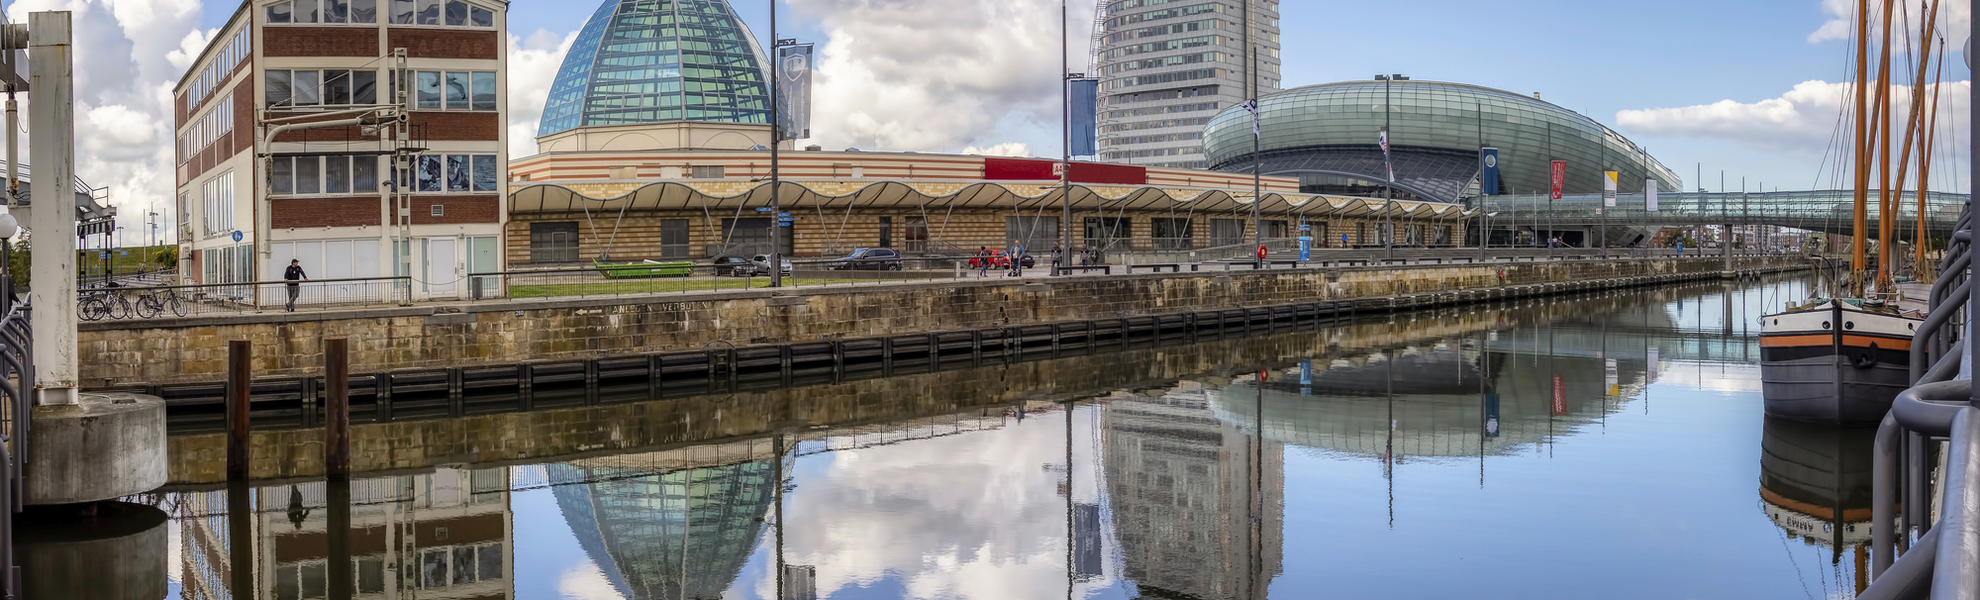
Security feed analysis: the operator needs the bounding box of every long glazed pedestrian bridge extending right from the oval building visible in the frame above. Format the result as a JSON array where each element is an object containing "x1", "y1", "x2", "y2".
[{"x1": 1467, "y1": 190, "x2": 1966, "y2": 240}]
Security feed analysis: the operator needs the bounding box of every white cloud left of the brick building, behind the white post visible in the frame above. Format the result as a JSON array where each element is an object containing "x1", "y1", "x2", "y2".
[{"x1": 6, "y1": 0, "x2": 200, "y2": 244}]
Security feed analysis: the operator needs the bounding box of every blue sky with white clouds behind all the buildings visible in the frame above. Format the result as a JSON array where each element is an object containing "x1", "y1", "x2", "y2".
[{"x1": 6, "y1": 0, "x2": 1970, "y2": 242}]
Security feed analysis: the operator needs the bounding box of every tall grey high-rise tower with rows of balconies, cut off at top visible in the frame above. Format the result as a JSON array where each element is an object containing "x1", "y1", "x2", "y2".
[{"x1": 1093, "y1": 0, "x2": 1279, "y2": 168}]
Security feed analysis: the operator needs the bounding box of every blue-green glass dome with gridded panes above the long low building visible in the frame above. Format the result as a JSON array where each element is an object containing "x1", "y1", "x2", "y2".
[{"x1": 537, "y1": 0, "x2": 770, "y2": 137}]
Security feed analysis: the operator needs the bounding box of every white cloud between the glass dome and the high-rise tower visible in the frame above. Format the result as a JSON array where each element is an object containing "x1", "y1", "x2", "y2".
[{"x1": 790, "y1": 0, "x2": 1093, "y2": 150}]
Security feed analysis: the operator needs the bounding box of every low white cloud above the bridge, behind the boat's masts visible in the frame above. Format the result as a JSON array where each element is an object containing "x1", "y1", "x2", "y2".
[{"x1": 1616, "y1": 81, "x2": 1970, "y2": 156}]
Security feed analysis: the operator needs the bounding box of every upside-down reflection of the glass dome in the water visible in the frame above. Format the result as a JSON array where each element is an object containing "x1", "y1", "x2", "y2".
[{"x1": 546, "y1": 440, "x2": 792, "y2": 600}]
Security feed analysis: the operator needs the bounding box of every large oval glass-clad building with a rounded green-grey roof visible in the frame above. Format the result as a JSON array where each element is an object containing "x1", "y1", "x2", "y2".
[{"x1": 1204, "y1": 79, "x2": 1683, "y2": 202}]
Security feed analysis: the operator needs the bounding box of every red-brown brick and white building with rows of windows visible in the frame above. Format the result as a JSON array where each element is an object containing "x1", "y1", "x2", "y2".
[{"x1": 172, "y1": 0, "x2": 509, "y2": 303}]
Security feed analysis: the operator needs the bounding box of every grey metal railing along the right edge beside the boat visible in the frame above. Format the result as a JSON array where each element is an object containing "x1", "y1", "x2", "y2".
[{"x1": 1857, "y1": 200, "x2": 1980, "y2": 598}]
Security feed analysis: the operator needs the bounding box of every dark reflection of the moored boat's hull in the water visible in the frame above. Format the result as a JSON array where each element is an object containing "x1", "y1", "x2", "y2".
[{"x1": 1760, "y1": 418, "x2": 1877, "y2": 596}]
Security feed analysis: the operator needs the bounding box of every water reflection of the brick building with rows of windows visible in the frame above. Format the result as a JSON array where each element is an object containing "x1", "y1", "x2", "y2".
[{"x1": 180, "y1": 467, "x2": 515, "y2": 600}]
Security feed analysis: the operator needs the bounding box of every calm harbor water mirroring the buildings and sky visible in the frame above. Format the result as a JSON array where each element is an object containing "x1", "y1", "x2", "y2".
[{"x1": 61, "y1": 279, "x2": 1869, "y2": 600}]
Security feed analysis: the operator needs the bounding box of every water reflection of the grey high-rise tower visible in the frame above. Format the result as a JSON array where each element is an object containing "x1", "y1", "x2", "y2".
[{"x1": 1101, "y1": 382, "x2": 1285, "y2": 598}]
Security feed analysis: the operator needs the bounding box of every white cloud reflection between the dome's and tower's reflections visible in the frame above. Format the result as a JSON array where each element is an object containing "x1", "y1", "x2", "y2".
[{"x1": 776, "y1": 412, "x2": 1093, "y2": 598}]
